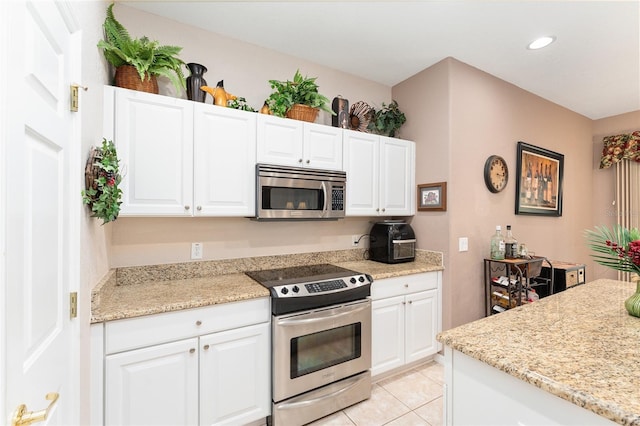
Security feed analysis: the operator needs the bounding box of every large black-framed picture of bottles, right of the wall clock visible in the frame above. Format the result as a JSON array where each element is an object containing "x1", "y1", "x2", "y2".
[{"x1": 516, "y1": 142, "x2": 564, "y2": 216}]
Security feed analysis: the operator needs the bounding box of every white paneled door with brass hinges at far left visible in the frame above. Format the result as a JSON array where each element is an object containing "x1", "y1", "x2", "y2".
[{"x1": 0, "y1": 1, "x2": 83, "y2": 425}]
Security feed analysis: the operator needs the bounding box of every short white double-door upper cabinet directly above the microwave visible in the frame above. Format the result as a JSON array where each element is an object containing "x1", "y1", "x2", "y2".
[{"x1": 257, "y1": 114, "x2": 342, "y2": 170}]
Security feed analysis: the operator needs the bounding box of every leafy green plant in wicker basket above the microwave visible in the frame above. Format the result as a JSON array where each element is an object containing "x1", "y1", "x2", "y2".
[{"x1": 266, "y1": 70, "x2": 335, "y2": 122}]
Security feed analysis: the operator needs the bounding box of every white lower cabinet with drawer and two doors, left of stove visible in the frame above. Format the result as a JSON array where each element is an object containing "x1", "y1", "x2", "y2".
[{"x1": 92, "y1": 298, "x2": 271, "y2": 425}]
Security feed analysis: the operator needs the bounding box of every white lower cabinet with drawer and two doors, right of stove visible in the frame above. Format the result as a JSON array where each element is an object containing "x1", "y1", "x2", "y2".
[{"x1": 371, "y1": 272, "x2": 442, "y2": 376}]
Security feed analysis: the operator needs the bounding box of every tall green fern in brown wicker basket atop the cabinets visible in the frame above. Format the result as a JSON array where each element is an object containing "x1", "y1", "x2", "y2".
[{"x1": 98, "y1": 3, "x2": 186, "y2": 93}]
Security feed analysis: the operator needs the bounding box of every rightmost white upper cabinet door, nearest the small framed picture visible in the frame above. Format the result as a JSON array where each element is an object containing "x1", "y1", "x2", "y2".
[{"x1": 380, "y1": 136, "x2": 415, "y2": 216}]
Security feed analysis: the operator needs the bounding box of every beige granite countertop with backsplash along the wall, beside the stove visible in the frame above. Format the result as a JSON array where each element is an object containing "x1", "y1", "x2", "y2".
[{"x1": 91, "y1": 250, "x2": 443, "y2": 323}]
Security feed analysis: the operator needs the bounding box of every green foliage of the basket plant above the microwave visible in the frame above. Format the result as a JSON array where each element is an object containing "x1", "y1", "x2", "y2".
[{"x1": 266, "y1": 70, "x2": 335, "y2": 117}]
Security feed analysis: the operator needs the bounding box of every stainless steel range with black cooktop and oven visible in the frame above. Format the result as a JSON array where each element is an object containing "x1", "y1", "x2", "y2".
[{"x1": 246, "y1": 264, "x2": 373, "y2": 426}]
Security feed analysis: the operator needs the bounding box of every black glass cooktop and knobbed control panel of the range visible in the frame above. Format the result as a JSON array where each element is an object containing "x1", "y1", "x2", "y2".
[{"x1": 245, "y1": 264, "x2": 373, "y2": 315}]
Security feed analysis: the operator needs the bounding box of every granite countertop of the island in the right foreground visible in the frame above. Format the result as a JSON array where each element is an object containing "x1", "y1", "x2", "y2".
[{"x1": 438, "y1": 279, "x2": 640, "y2": 425}]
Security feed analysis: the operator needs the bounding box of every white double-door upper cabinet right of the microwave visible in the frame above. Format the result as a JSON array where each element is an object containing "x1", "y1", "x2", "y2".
[{"x1": 344, "y1": 130, "x2": 415, "y2": 216}]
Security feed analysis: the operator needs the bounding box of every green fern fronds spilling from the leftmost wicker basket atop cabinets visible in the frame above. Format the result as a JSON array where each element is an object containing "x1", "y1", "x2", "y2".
[{"x1": 98, "y1": 3, "x2": 187, "y2": 91}]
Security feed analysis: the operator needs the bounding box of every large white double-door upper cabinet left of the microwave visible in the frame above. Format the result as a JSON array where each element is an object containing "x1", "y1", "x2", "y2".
[{"x1": 104, "y1": 86, "x2": 257, "y2": 217}]
